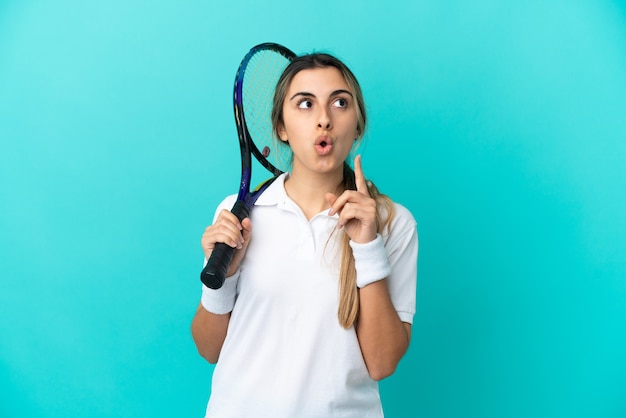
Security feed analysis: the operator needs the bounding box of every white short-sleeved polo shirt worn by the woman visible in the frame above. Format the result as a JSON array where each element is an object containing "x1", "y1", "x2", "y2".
[{"x1": 203, "y1": 174, "x2": 418, "y2": 418}]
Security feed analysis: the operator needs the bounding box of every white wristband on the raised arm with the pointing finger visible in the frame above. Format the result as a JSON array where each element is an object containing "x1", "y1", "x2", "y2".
[{"x1": 350, "y1": 234, "x2": 391, "y2": 289}]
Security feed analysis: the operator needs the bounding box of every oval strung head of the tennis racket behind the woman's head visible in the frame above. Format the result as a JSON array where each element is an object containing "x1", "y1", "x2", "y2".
[{"x1": 234, "y1": 42, "x2": 296, "y2": 181}]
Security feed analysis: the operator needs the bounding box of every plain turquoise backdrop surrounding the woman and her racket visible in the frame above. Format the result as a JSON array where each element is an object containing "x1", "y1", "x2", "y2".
[{"x1": 0, "y1": 0, "x2": 626, "y2": 418}]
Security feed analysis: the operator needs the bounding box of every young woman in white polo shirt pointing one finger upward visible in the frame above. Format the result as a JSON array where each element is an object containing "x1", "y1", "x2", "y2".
[{"x1": 192, "y1": 50, "x2": 418, "y2": 418}]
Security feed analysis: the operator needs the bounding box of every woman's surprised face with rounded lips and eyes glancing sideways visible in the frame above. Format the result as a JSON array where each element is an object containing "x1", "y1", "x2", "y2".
[{"x1": 278, "y1": 67, "x2": 359, "y2": 174}]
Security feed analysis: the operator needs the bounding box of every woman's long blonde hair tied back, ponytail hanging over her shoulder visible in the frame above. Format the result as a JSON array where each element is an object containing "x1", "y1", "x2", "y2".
[{"x1": 271, "y1": 54, "x2": 394, "y2": 329}]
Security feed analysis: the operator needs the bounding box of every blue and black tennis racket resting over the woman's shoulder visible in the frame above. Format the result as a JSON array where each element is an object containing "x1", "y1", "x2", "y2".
[{"x1": 200, "y1": 43, "x2": 296, "y2": 289}]
